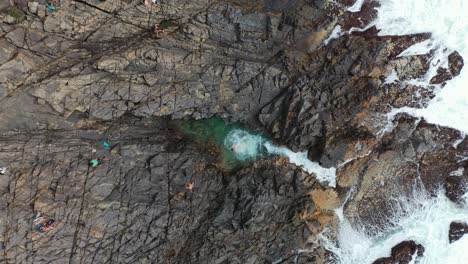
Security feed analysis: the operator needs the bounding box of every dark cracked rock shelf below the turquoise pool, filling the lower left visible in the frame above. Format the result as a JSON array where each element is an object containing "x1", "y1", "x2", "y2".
[{"x1": 0, "y1": 118, "x2": 324, "y2": 263}]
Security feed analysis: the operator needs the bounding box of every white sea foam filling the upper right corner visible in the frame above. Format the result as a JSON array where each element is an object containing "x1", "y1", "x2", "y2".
[{"x1": 372, "y1": 0, "x2": 468, "y2": 132}]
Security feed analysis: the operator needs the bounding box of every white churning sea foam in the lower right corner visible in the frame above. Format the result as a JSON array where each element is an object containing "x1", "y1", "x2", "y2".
[{"x1": 321, "y1": 191, "x2": 468, "y2": 264}]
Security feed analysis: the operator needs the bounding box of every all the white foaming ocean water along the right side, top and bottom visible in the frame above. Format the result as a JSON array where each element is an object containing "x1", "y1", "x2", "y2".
[{"x1": 322, "y1": 0, "x2": 468, "y2": 264}]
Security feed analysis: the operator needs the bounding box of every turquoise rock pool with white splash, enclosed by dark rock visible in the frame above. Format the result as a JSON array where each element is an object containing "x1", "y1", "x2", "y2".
[{"x1": 177, "y1": 117, "x2": 269, "y2": 171}]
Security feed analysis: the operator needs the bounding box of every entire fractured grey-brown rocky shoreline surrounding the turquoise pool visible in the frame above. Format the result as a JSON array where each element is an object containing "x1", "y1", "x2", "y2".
[{"x1": 0, "y1": 0, "x2": 468, "y2": 264}]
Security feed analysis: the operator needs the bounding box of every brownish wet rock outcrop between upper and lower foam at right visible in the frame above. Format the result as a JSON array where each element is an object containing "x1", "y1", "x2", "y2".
[{"x1": 338, "y1": 117, "x2": 464, "y2": 226}]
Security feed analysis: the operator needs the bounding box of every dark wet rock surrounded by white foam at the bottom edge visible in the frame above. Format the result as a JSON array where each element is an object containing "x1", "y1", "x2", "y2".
[{"x1": 373, "y1": 241, "x2": 424, "y2": 264}]
